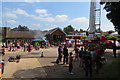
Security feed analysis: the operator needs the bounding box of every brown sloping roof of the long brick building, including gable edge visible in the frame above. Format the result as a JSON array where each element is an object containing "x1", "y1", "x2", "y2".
[{"x1": 3, "y1": 28, "x2": 66, "y2": 39}]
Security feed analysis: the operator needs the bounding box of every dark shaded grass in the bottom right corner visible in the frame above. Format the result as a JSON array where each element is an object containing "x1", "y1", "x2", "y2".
[{"x1": 97, "y1": 56, "x2": 120, "y2": 78}]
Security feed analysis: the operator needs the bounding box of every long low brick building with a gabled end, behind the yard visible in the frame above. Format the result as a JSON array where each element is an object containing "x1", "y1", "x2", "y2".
[{"x1": 0, "y1": 27, "x2": 66, "y2": 45}]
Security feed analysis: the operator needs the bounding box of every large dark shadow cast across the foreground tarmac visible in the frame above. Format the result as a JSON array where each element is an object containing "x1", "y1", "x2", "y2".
[{"x1": 6, "y1": 49, "x2": 120, "y2": 78}]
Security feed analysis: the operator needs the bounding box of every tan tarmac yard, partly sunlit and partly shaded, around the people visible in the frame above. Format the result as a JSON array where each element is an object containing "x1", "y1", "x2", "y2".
[{"x1": 2, "y1": 47, "x2": 120, "y2": 78}]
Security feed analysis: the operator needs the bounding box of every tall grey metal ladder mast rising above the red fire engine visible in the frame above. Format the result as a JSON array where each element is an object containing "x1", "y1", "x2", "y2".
[{"x1": 88, "y1": 0, "x2": 101, "y2": 38}]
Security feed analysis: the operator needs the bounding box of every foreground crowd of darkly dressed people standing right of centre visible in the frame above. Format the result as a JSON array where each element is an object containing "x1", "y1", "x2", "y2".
[{"x1": 58, "y1": 46, "x2": 104, "y2": 77}]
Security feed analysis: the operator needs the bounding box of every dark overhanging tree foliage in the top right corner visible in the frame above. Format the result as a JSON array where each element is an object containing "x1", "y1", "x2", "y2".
[{"x1": 100, "y1": 0, "x2": 120, "y2": 35}]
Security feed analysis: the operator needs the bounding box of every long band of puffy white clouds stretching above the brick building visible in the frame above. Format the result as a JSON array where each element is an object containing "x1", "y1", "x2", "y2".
[{"x1": 13, "y1": 8, "x2": 68, "y2": 22}]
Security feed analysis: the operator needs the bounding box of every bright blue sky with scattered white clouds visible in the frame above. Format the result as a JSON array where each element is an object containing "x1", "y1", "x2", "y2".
[{"x1": 0, "y1": 0, "x2": 114, "y2": 31}]
